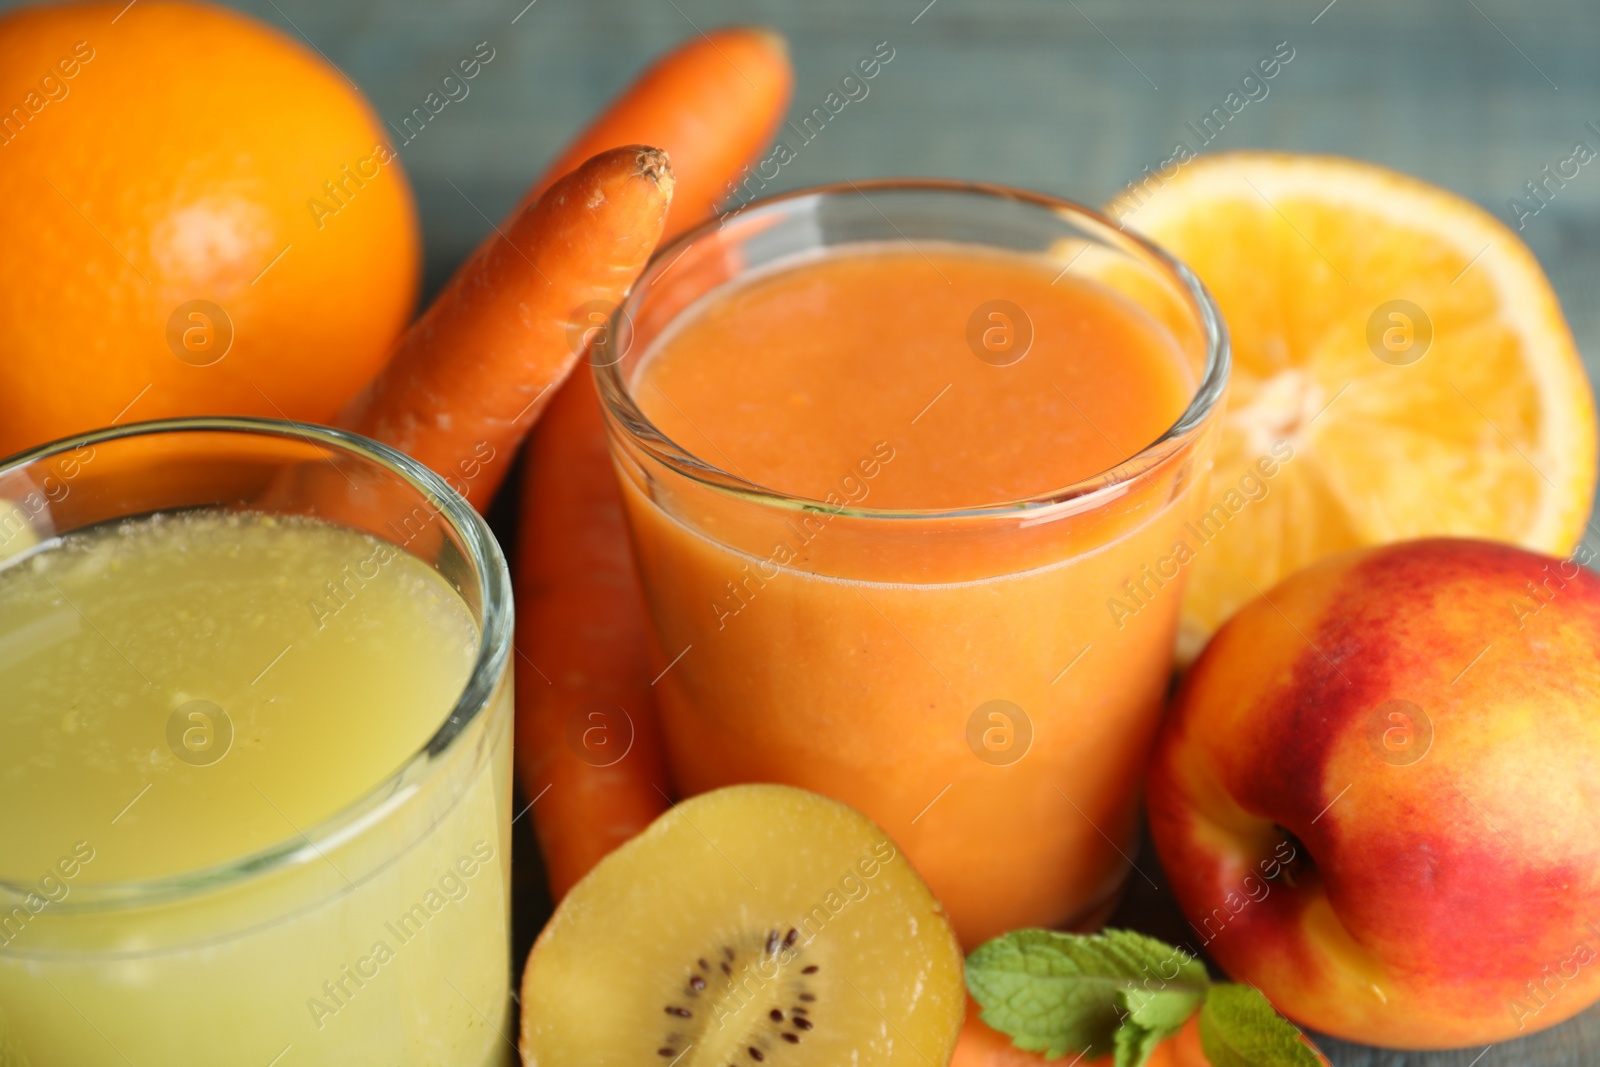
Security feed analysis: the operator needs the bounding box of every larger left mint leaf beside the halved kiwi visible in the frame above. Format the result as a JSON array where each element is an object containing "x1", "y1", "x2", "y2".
[{"x1": 966, "y1": 929, "x2": 1210, "y2": 1065}]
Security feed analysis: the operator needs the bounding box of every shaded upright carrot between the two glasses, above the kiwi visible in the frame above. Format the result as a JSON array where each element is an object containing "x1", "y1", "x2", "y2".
[{"x1": 515, "y1": 374, "x2": 672, "y2": 901}]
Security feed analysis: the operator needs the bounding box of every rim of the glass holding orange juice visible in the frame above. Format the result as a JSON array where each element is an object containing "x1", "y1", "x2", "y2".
[{"x1": 590, "y1": 178, "x2": 1232, "y2": 522}]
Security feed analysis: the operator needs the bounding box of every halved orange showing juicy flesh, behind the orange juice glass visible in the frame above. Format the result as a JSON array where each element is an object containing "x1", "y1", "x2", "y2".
[{"x1": 1107, "y1": 152, "x2": 1595, "y2": 662}]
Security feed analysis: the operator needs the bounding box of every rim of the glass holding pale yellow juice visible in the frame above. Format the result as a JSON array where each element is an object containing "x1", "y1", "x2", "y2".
[{"x1": 0, "y1": 416, "x2": 512, "y2": 908}]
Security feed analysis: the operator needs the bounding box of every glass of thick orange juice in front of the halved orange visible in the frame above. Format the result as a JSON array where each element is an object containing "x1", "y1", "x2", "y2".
[{"x1": 592, "y1": 181, "x2": 1229, "y2": 947}]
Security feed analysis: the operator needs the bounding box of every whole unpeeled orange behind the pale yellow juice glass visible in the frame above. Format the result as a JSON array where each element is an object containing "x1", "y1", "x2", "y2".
[{"x1": 0, "y1": 0, "x2": 419, "y2": 456}]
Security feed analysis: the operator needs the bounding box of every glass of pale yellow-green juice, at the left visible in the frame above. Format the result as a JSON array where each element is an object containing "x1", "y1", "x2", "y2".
[{"x1": 0, "y1": 418, "x2": 515, "y2": 1067}]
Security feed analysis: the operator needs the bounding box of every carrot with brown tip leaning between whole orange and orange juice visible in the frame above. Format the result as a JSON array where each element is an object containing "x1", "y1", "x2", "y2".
[{"x1": 339, "y1": 144, "x2": 674, "y2": 507}]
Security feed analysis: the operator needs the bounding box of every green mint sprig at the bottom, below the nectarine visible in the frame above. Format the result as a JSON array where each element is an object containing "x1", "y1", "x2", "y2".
[{"x1": 966, "y1": 929, "x2": 1322, "y2": 1067}]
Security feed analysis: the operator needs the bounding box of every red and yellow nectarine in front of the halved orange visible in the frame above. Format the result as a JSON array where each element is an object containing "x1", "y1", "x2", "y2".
[{"x1": 1147, "y1": 539, "x2": 1600, "y2": 1048}]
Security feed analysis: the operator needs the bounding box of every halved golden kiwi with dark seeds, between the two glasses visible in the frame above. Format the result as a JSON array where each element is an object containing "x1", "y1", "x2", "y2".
[{"x1": 522, "y1": 785, "x2": 966, "y2": 1067}]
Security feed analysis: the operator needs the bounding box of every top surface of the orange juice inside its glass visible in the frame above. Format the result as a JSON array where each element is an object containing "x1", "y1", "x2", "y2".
[{"x1": 634, "y1": 250, "x2": 1194, "y2": 509}]
